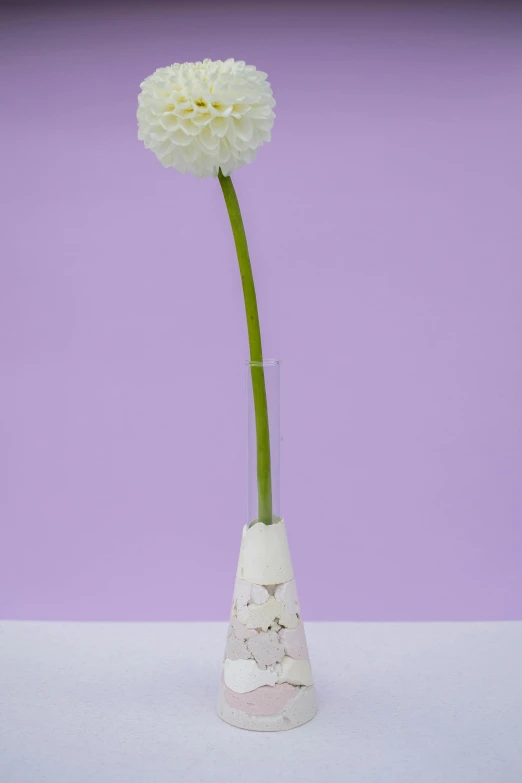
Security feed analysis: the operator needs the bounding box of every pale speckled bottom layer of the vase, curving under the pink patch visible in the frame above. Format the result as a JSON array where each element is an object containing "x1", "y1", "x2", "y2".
[{"x1": 217, "y1": 685, "x2": 317, "y2": 731}]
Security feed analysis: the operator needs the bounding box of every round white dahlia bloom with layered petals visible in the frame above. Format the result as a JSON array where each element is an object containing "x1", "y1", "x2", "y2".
[{"x1": 138, "y1": 59, "x2": 275, "y2": 177}]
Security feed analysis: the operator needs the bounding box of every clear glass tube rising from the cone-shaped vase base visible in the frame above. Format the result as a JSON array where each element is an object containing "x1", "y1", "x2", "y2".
[{"x1": 246, "y1": 359, "x2": 281, "y2": 524}]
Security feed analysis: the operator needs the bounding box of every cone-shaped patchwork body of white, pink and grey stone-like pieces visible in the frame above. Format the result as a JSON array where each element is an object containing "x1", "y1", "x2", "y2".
[{"x1": 218, "y1": 519, "x2": 317, "y2": 731}]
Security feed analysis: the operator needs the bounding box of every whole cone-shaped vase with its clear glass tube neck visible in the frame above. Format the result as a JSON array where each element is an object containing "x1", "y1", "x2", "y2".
[{"x1": 218, "y1": 360, "x2": 317, "y2": 731}]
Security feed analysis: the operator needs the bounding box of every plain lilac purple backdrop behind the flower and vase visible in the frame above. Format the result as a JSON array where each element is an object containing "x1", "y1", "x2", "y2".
[{"x1": 0, "y1": 4, "x2": 522, "y2": 620}]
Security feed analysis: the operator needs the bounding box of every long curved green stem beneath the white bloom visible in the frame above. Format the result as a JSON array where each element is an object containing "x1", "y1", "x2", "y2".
[{"x1": 219, "y1": 169, "x2": 273, "y2": 525}]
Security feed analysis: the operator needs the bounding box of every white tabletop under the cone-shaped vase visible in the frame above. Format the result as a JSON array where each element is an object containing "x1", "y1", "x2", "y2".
[{"x1": 0, "y1": 622, "x2": 522, "y2": 783}]
